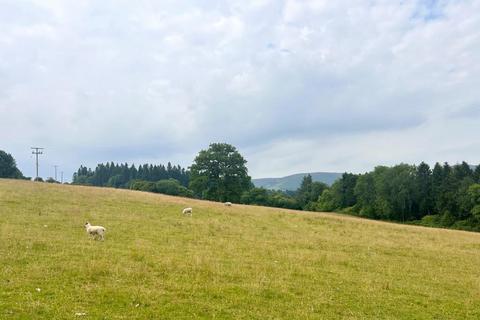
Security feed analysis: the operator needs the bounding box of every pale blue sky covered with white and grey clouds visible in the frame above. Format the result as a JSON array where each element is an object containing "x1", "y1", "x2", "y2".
[{"x1": 0, "y1": 0, "x2": 480, "y2": 180}]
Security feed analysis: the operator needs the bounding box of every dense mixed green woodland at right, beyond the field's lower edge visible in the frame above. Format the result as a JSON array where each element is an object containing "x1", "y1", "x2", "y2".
[{"x1": 312, "y1": 162, "x2": 480, "y2": 230}]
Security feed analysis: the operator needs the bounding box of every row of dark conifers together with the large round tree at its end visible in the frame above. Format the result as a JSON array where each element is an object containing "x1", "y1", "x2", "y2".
[{"x1": 72, "y1": 143, "x2": 252, "y2": 202}]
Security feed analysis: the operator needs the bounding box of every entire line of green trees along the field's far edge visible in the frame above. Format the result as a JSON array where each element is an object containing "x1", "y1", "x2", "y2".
[{"x1": 0, "y1": 143, "x2": 480, "y2": 231}]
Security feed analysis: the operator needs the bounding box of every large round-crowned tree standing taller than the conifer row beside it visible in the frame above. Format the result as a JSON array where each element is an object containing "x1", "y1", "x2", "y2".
[{"x1": 190, "y1": 143, "x2": 252, "y2": 202}]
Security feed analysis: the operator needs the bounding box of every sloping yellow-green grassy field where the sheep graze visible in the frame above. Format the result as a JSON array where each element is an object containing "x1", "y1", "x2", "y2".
[{"x1": 0, "y1": 180, "x2": 480, "y2": 319}]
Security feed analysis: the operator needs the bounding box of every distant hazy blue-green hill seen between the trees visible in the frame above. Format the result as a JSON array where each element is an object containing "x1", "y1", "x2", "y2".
[{"x1": 252, "y1": 172, "x2": 342, "y2": 190}]
